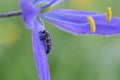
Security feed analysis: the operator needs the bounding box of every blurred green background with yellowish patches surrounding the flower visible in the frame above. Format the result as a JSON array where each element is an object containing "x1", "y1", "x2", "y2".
[{"x1": 0, "y1": 0, "x2": 120, "y2": 80}]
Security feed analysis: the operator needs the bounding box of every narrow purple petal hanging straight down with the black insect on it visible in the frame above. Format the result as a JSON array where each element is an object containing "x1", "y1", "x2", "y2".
[{"x1": 32, "y1": 29, "x2": 50, "y2": 80}]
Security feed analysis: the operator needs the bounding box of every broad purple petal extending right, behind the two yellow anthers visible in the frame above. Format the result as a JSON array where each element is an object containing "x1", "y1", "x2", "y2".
[{"x1": 42, "y1": 9, "x2": 120, "y2": 35}]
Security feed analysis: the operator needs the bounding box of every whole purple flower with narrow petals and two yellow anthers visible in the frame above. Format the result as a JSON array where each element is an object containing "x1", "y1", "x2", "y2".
[{"x1": 20, "y1": 0, "x2": 120, "y2": 80}]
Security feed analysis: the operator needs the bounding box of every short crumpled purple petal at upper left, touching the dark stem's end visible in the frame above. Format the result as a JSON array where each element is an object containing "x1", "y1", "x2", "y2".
[{"x1": 20, "y1": 0, "x2": 39, "y2": 29}]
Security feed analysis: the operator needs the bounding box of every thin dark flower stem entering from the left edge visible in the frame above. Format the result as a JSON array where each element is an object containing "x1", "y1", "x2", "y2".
[{"x1": 0, "y1": 10, "x2": 22, "y2": 18}]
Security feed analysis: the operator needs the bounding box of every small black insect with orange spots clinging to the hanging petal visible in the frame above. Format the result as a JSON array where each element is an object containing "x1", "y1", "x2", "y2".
[{"x1": 39, "y1": 30, "x2": 52, "y2": 54}]
